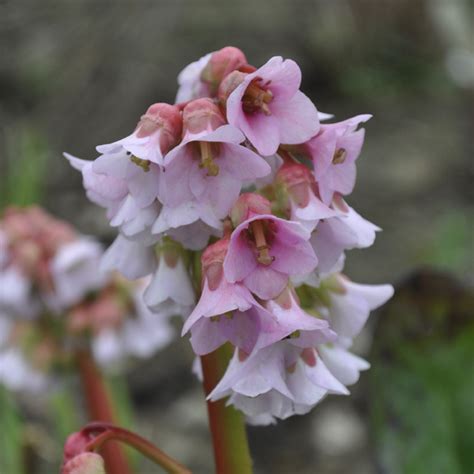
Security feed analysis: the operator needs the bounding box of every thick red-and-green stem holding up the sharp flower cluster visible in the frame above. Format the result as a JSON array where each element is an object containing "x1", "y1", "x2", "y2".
[{"x1": 201, "y1": 345, "x2": 252, "y2": 474}]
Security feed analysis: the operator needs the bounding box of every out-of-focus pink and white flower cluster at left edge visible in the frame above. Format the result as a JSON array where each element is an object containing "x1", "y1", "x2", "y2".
[{"x1": 0, "y1": 207, "x2": 172, "y2": 390}]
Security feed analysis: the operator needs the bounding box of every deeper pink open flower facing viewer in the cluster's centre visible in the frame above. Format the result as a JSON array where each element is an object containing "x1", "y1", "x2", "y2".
[{"x1": 224, "y1": 195, "x2": 318, "y2": 299}]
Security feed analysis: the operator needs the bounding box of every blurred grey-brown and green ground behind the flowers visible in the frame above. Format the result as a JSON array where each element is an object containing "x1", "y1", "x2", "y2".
[{"x1": 0, "y1": 0, "x2": 474, "y2": 474}]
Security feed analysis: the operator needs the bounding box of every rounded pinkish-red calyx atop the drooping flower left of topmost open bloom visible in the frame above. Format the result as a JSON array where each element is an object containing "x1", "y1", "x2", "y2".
[{"x1": 183, "y1": 98, "x2": 225, "y2": 135}]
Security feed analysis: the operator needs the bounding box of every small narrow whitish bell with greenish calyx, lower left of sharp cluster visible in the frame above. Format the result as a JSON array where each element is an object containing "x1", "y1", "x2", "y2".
[{"x1": 144, "y1": 239, "x2": 195, "y2": 317}]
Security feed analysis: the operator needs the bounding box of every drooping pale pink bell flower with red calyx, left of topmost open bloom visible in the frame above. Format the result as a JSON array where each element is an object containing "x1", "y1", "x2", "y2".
[{"x1": 160, "y1": 99, "x2": 271, "y2": 219}]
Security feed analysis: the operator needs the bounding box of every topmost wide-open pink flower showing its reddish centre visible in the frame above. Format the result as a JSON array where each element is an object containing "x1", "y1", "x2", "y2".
[{"x1": 226, "y1": 56, "x2": 319, "y2": 156}]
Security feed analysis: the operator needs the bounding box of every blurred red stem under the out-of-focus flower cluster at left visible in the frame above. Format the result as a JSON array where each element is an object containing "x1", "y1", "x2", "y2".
[{"x1": 76, "y1": 351, "x2": 132, "y2": 474}]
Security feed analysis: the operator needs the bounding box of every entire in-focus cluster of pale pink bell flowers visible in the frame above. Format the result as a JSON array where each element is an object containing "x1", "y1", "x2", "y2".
[{"x1": 66, "y1": 47, "x2": 393, "y2": 424}]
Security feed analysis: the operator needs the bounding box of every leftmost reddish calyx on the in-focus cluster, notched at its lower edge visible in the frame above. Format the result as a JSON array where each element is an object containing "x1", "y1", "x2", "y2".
[{"x1": 136, "y1": 103, "x2": 183, "y2": 153}]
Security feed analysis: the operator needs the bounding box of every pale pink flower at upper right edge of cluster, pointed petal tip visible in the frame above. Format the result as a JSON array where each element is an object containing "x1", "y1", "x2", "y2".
[{"x1": 306, "y1": 114, "x2": 372, "y2": 204}]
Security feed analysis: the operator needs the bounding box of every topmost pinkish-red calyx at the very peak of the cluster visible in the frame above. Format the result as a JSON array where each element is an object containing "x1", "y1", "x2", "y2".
[{"x1": 201, "y1": 46, "x2": 247, "y2": 95}]
